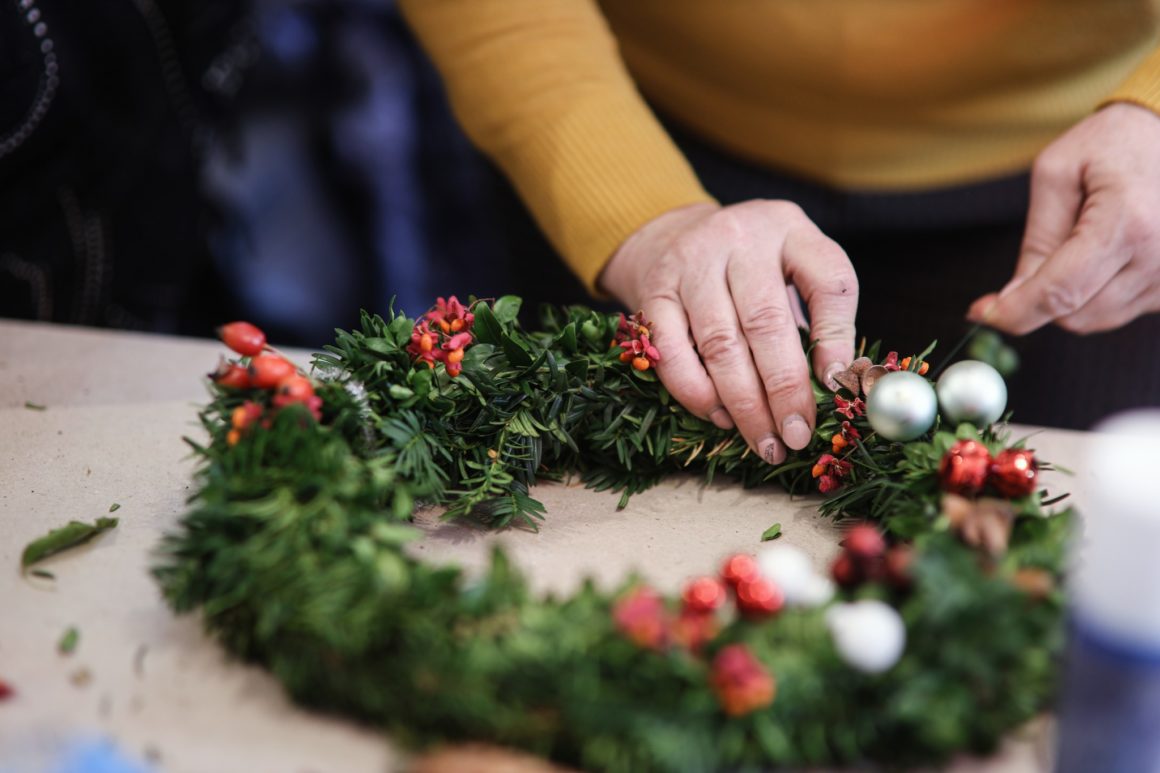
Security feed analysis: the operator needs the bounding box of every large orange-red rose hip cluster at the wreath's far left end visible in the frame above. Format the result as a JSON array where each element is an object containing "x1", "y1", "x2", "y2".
[{"x1": 210, "y1": 322, "x2": 322, "y2": 446}]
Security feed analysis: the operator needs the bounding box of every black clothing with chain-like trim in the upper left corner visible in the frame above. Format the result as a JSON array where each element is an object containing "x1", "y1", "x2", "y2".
[{"x1": 0, "y1": 0, "x2": 240, "y2": 332}]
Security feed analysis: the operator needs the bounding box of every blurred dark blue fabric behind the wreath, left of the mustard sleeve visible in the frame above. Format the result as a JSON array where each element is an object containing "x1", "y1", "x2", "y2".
[{"x1": 205, "y1": 0, "x2": 512, "y2": 346}]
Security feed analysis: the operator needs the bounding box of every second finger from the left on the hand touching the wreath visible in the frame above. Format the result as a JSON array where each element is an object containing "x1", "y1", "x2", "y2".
[{"x1": 681, "y1": 270, "x2": 785, "y2": 464}]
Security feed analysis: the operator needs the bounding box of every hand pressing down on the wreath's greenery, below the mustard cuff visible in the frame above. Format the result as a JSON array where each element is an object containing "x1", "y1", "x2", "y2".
[{"x1": 600, "y1": 201, "x2": 858, "y2": 464}]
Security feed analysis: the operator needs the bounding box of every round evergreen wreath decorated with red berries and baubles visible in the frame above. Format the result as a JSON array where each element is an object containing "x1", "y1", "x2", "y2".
[{"x1": 154, "y1": 297, "x2": 1068, "y2": 771}]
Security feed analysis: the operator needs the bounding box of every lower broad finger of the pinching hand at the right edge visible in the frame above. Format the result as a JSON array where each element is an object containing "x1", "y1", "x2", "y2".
[{"x1": 983, "y1": 208, "x2": 1131, "y2": 335}]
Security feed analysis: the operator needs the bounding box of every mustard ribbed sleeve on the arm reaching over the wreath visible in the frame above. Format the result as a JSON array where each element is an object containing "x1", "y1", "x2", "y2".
[{"x1": 400, "y1": 0, "x2": 711, "y2": 291}]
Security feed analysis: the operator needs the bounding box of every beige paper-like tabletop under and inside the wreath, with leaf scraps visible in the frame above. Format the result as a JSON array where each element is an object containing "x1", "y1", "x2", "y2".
[{"x1": 0, "y1": 320, "x2": 1087, "y2": 773}]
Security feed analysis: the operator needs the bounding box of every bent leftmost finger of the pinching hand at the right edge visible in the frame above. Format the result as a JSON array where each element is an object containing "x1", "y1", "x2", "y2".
[{"x1": 966, "y1": 153, "x2": 1083, "y2": 322}]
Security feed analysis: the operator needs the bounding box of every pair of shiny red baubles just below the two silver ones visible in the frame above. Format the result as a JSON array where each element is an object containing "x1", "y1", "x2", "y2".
[{"x1": 938, "y1": 440, "x2": 1039, "y2": 499}]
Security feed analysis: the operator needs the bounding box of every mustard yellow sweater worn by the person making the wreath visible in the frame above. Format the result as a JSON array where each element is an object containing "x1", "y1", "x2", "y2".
[{"x1": 401, "y1": 0, "x2": 1160, "y2": 287}]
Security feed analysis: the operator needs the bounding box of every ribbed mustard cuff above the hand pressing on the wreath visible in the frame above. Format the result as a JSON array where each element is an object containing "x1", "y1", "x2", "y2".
[{"x1": 495, "y1": 93, "x2": 713, "y2": 296}]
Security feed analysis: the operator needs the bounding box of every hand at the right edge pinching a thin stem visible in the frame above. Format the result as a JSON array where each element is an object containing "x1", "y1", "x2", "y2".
[{"x1": 967, "y1": 103, "x2": 1160, "y2": 335}]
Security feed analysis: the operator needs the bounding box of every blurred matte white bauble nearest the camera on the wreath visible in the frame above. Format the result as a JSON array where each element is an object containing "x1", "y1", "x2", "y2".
[{"x1": 826, "y1": 599, "x2": 906, "y2": 673}]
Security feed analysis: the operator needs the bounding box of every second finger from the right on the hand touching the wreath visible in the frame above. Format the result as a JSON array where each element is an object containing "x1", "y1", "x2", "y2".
[{"x1": 726, "y1": 247, "x2": 817, "y2": 449}]
